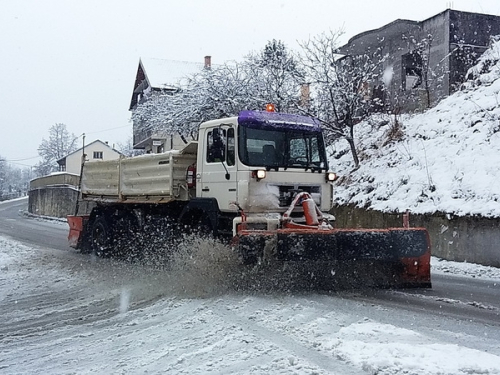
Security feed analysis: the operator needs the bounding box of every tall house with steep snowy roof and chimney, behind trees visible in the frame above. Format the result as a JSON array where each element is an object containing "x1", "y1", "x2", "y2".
[{"x1": 129, "y1": 56, "x2": 211, "y2": 153}]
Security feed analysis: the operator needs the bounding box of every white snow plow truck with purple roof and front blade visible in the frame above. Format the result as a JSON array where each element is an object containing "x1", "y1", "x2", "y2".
[{"x1": 68, "y1": 111, "x2": 431, "y2": 287}]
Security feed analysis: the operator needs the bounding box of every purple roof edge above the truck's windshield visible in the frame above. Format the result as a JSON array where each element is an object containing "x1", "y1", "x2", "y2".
[{"x1": 238, "y1": 111, "x2": 321, "y2": 132}]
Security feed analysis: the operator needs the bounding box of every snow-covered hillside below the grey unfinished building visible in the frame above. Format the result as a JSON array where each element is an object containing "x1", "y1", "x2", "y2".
[{"x1": 330, "y1": 37, "x2": 500, "y2": 217}]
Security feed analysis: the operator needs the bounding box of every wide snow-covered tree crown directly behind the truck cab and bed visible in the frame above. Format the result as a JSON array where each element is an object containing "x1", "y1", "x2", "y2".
[{"x1": 132, "y1": 40, "x2": 303, "y2": 139}]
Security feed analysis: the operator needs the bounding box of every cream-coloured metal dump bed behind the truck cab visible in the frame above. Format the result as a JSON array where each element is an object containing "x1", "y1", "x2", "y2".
[{"x1": 81, "y1": 142, "x2": 196, "y2": 203}]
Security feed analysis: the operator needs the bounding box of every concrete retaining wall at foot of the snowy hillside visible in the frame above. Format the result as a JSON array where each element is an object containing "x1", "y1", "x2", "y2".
[{"x1": 333, "y1": 207, "x2": 500, "y2": 267}]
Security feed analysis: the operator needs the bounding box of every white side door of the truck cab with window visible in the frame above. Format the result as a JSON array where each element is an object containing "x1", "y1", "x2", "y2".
[{"x1": 201, "y1": 126, "x2": 237, "y2": 211}]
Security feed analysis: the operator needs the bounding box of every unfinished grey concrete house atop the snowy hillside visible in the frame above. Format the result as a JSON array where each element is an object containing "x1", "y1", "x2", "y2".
[{"x1": 339, "y1": 9, "x2": 500, "y2": 111}]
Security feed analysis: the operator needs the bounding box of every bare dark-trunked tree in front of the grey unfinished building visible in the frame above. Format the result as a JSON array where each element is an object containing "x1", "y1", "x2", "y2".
[{"x1": 301, "y1": 31, "x2": 383, "y2": 168}]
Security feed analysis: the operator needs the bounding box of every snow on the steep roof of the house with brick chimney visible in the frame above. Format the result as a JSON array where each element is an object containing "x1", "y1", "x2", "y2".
[{"x1": 141, "y1": 57, "x2": 204, "y2": 89}]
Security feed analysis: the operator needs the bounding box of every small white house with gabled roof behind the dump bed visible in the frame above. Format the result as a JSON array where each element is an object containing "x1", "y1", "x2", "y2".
[{"x1": 57, "y1": 140, "x2": 121, "y2": 175}]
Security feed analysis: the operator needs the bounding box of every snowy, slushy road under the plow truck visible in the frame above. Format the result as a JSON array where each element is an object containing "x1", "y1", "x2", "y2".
[{"x1": 0, "y1": 198, "x2": 500, "y2": 374}]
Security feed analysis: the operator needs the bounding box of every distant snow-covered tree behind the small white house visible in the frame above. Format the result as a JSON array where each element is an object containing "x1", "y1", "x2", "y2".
[{"x1": 35, "y1": 123, "x2": 77, "y2": 176}]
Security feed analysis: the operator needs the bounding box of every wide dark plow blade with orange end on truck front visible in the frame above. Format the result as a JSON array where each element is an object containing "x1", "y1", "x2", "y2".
[{"x1": 237, "y1": 228, "x2": 431, "y2": 287}]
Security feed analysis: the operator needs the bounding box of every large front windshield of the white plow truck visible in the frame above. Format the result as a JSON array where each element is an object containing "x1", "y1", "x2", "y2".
[{"x1": 238, "y1": 125, "x2": 327, "y2": 170}]
